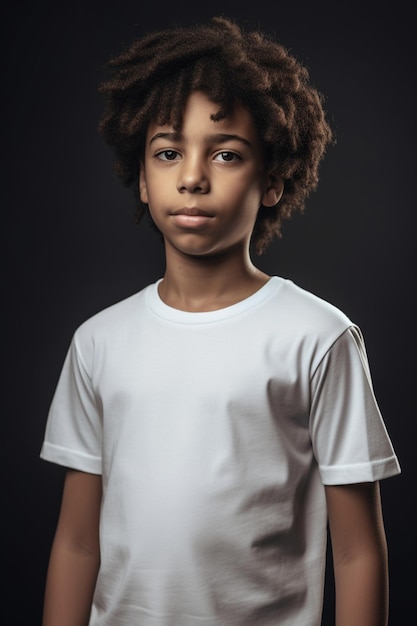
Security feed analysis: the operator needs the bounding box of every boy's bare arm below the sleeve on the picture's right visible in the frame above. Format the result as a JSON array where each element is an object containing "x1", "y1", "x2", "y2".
[{"x1": 326, "y1": 482, "x2": 388, "y2": 626}]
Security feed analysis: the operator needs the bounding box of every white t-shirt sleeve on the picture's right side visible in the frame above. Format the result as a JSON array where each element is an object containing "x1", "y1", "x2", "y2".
[{"x1": 310, "y1": 326, "x2": 400, "y2": 485}]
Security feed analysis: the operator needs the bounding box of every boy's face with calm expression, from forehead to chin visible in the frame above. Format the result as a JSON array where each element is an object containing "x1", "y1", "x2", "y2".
[{"x1": 140, "y1": 92, "x2": 279, "y2": 256}]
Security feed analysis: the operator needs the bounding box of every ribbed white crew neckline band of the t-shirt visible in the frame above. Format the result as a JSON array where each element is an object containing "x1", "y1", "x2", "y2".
[{"x1": 146, "y1": 276, "x2": 284, "y2": 324}]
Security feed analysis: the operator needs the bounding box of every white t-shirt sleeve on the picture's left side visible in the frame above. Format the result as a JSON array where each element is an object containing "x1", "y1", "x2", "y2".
[{"x1": 40, "y1": 336, "x2": 102, "y2": 474}]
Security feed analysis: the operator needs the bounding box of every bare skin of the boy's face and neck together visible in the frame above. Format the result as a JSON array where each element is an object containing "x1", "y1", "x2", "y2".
[{"x1": 139, "y1": 92, "x2": 283, "y2": 311}]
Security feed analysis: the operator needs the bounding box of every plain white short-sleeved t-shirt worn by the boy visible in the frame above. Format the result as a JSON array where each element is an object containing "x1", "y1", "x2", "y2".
[{"x1": 41, "y1": 276, "x2": 400, "y2": 626}]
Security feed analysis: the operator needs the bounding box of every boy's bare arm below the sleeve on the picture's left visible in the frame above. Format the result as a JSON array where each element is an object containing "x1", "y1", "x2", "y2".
[{"x1": 42, "y1": 470, "x2": 101, "y2": 626}]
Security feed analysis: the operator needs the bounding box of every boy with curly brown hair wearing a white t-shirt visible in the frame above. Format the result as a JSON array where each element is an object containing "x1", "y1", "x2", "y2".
[{"x1": 41, "y1": 18, "x2": 400, "y2": 626}]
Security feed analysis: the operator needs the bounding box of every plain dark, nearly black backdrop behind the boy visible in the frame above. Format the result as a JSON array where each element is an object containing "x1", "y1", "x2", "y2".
[{"x1": 0, "y1": 0, "x2": 417, "y2": 626}]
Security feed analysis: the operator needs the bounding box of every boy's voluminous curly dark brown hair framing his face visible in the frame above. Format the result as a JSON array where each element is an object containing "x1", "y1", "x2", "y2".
[{"x1": 98, "y1": 17, "x2": 333, "y2": 254}]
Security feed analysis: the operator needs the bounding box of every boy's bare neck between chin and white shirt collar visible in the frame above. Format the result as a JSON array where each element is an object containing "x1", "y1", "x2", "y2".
[{"x1": 159, "y1": 244, "x2": 269, "y2": 312}]
